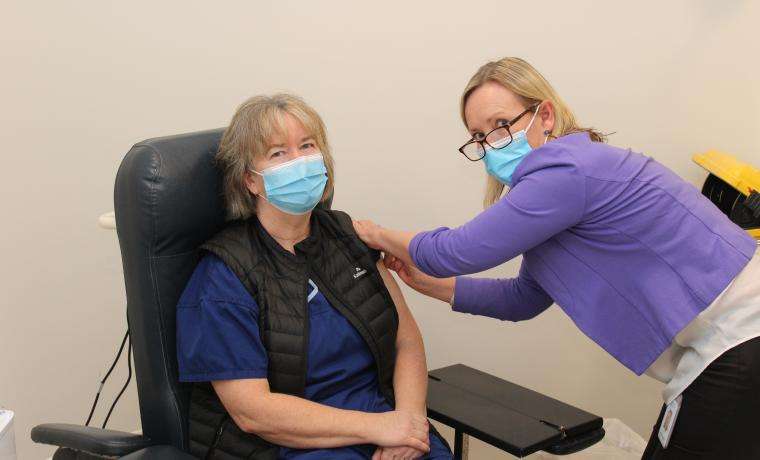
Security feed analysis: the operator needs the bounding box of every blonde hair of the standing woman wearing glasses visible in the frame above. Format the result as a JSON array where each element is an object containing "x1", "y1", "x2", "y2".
[{"x1": 460, "y1": 57, "x2": 606, "y2": 207}]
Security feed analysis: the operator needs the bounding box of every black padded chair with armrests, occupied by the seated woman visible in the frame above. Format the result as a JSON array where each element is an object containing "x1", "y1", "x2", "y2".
[{"x1": 32, "y1": 129, "x2": 604, "y2": 460}]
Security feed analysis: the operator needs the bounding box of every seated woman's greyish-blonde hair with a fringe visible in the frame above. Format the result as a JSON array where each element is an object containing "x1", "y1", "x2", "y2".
[{"x1": 216, "y1": 93, "x2": 335, "y2": 219}]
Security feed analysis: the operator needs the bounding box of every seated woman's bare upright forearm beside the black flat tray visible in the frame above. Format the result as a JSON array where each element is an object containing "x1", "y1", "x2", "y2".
[{"x1": 393, "y1": 337, "x2": 428, "y2": 415}]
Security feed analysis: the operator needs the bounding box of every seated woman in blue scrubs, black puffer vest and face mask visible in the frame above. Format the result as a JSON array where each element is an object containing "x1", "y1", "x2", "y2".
[{"x1": 177, "y1": 94, "x2": 451, "y2": 459}]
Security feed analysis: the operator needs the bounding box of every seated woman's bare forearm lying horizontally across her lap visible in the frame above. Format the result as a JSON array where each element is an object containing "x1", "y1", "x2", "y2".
[{"x1": 236, "y1": 393, "x2": 375, "y2": 449}]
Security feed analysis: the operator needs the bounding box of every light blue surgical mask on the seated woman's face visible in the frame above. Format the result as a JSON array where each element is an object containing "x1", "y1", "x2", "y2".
[{"x1": 251, "y1": 153, "x2": 327, "y2": 214}]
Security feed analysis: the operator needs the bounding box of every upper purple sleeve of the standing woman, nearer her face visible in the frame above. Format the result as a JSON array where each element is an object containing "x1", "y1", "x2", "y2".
[{"x1": 409, "y1": 163, "x2": 586, "y2": 277}]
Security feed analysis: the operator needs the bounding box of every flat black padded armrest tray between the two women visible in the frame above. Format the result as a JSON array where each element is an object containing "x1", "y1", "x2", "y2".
[{"x1": 427, "y1": 364, "x2": 604, "y2": 457}]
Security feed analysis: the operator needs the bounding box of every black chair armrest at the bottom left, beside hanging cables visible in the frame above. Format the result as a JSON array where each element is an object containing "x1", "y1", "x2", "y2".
[{"x1": 32, "y1": 423, "x2": 154, "y2": 457}]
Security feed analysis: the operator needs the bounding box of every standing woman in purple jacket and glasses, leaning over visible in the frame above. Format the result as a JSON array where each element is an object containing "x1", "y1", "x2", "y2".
[{"x1": 354, "y1": 58, "x2": 760, "y2": 459}]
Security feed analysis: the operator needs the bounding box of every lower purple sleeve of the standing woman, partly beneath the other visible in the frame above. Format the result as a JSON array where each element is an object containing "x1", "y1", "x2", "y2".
[{"x1": 453, "y1": 264, "x2": 554, "y2": 321}]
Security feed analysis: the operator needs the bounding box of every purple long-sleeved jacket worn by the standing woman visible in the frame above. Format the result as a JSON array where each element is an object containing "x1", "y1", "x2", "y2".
[{"x1": 409, "y1": 133, "x2": 757, "y2": 375}]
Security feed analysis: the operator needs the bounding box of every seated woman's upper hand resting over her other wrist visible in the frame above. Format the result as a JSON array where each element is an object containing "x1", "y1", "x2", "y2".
[{"x1": 369, "y1": 410, "x2": 430, "y2": 453}]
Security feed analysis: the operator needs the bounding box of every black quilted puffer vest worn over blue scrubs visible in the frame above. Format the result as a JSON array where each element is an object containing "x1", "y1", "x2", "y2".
[{"x1": 189, "y1": 208, "x2": 398, "y2": 460}]
